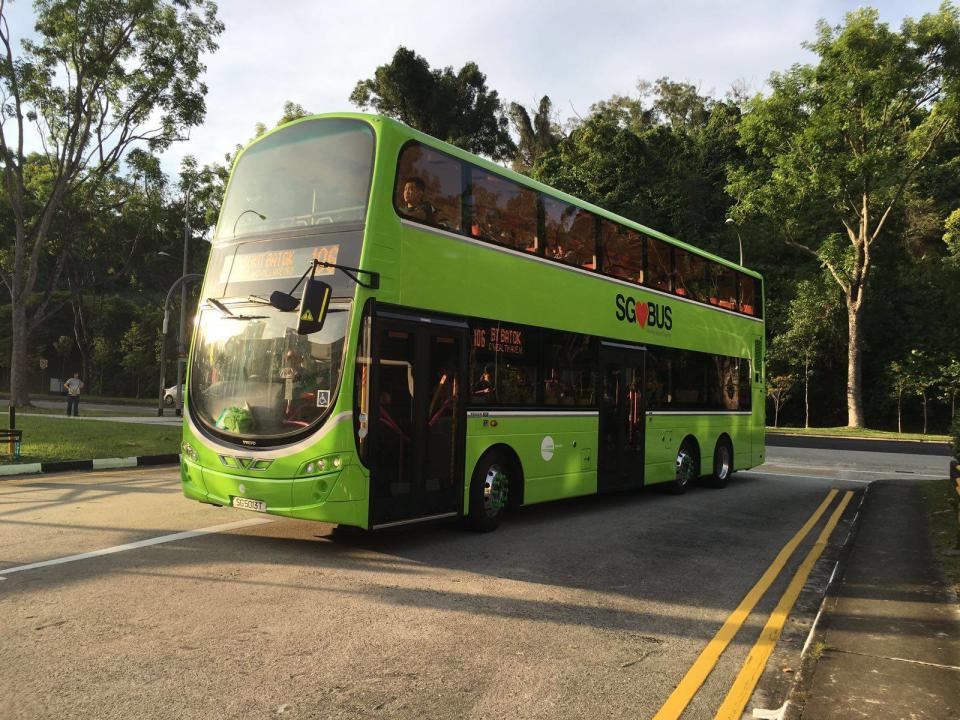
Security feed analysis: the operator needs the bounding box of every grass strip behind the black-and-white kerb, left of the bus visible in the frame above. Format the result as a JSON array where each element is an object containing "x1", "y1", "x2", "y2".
[{"x1": 0, "y1": 416, "x2": 181, "y2": 464}]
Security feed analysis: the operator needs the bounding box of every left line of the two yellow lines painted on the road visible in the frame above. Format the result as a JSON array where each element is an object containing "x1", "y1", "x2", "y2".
[{"x1": 653, "y1": 490, "x2": 837, "y2": 720}]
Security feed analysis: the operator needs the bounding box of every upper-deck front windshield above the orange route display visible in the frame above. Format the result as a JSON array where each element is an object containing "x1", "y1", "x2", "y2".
[{"x1": 216, "y1": 118, "x2": 374, "y2": 241}]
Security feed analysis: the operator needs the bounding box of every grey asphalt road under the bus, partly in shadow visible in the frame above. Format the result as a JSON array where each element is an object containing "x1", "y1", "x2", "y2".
[{"x1": 0, "y1": 448, "x2": 946, "y2": 720}]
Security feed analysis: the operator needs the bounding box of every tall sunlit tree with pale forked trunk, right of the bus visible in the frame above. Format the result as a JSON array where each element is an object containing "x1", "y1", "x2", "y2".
[{"x1": 730, "y1": 3, "x2": 960, "y2": 427}]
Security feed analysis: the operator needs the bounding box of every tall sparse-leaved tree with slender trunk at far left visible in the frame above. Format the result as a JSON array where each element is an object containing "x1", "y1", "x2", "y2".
[{"x1": 0, "y1": 0, "x2": 223, "y2": 405}]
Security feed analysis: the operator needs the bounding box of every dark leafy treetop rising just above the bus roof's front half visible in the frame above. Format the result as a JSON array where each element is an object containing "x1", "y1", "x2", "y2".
[{"x1": 350, "y1": 47, "x2": 516, "y2": 160}]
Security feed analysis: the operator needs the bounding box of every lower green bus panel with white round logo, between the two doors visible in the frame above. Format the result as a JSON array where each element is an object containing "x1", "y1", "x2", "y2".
[{"x1": 463, "y1": 412, "x2": 597, "y2": 513}]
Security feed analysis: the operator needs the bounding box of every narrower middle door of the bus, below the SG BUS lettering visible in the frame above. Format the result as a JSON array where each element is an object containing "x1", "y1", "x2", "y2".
[{"x1": 597, "y1": 343, "x2": 646, "y2": 492}]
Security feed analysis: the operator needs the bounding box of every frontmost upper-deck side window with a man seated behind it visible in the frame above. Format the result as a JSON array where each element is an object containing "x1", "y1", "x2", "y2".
[{"x1": 394, "y1": 143, "x2": 463, "y2": 232}]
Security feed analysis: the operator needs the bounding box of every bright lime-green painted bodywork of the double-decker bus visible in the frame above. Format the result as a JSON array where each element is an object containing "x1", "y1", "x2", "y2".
[{"x1": 181, "y1": 113, "x2": 765, "y2": 527}]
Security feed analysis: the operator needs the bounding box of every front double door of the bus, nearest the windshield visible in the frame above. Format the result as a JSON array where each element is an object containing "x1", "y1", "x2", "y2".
[{"x1": 369, "y1": 313, "x2": 467, "y2": 527}]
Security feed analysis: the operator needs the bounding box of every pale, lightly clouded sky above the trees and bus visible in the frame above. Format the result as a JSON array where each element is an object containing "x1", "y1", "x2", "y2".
[{"x1": 1, "y1": 0, "x2": 939, "y2": 174}]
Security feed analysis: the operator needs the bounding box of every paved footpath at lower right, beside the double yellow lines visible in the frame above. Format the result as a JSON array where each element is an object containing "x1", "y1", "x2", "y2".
[{"x1": 800, "y1": 481, "x2": 960, "y2": 720}]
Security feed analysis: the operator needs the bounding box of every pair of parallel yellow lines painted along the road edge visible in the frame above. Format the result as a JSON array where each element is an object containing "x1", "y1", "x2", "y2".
[{"x1": 653, "y1": 490, "x2": 853, "y2": 720}]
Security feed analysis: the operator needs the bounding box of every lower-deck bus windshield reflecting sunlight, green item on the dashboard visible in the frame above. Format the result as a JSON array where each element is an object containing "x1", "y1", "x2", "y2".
[{"x1": 190, "y1": 301, "x2": 350, "y2": 440}]
